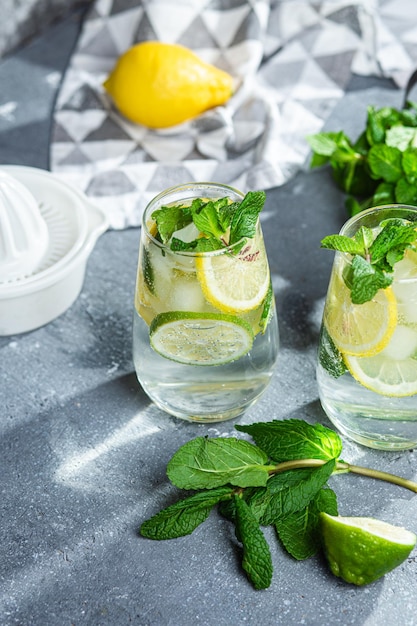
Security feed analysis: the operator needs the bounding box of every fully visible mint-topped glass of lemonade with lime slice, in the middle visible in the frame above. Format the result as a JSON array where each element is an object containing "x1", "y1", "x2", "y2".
[{"x1": 133, "y1": 183, "x2": 279, "y2": 422}]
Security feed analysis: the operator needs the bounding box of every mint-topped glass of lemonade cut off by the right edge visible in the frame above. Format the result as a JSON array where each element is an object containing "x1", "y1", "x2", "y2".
[{"x1": 317, "y1": 205, "x2": 417, "y2": 450}]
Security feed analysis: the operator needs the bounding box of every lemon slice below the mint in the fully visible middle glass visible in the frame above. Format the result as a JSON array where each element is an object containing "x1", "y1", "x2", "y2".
[{"x1": 196, "y1": 236, "x2": 270, "y2": 313}]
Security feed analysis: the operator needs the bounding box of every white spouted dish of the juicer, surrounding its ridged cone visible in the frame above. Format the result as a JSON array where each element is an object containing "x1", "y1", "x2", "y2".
[{"x1": 0, "y1": 165, "x2": 108, "y2": 335}]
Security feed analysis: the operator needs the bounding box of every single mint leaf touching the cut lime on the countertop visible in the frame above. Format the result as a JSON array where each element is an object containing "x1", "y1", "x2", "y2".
[{"x1": 275, "y1": 488, "x2": 338, "y2": 561}]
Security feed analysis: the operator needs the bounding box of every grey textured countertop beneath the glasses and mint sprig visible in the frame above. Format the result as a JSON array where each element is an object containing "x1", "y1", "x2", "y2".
[{"x1": 0, "y1": 9, "x2": 417, "y2": 626}]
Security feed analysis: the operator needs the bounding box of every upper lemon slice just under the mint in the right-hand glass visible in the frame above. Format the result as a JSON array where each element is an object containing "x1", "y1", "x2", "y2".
[{"x1": 324, "y1": 274, "x2": 397, "y2": 357}]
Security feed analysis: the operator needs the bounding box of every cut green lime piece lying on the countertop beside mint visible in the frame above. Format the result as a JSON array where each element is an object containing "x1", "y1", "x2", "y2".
[{"x1": 320, "y1": 513, "x2": 417, "y2": 585}]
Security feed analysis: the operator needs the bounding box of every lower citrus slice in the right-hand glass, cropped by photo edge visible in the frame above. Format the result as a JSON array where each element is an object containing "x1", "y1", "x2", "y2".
[{"x1": 344, "y1": 325, "x2": 417, "y2": 397}]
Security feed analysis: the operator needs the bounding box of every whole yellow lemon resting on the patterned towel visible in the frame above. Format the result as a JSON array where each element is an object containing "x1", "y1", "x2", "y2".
[{"x1": 104, "y1": 41, "x2": 233, "y2": 128}]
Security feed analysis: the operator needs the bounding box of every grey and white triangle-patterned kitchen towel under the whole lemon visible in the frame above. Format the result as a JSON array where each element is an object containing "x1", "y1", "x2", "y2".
[{"x1": 50, "y1": 0, "x2": 417, "y2": 229}]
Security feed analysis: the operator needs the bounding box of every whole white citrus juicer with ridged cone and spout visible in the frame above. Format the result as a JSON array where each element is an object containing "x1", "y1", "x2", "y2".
[{"x1": 0, "y1": 165, "x2": 108, "y2": 335}]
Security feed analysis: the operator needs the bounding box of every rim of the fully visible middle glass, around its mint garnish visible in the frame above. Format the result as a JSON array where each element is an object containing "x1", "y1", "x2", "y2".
[{"x1": 142, "y1": 181, "x2": 248, "y2": 257}]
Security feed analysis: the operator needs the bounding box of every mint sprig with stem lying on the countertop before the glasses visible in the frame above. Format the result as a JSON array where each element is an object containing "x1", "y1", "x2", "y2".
[{"x1": 140, "y1": 419, "x2": 417, "y2": 589}]
